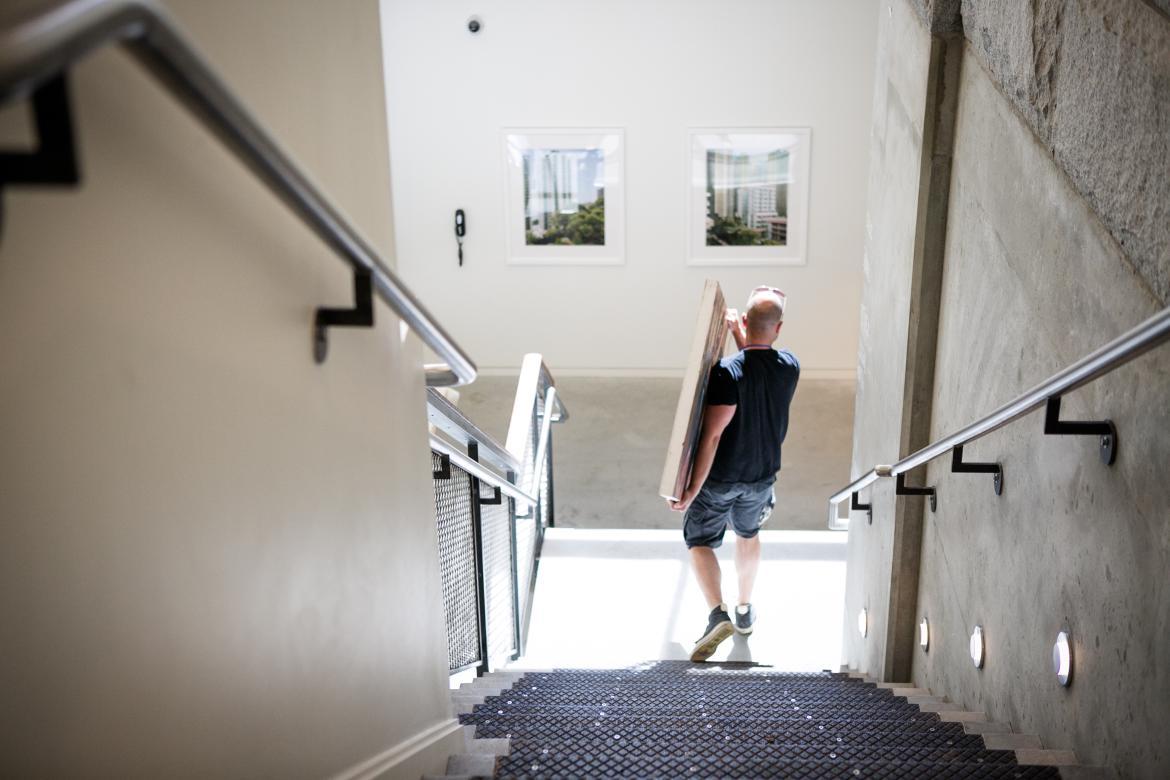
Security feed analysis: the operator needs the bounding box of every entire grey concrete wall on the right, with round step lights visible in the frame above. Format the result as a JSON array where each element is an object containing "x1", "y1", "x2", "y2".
[{"x1": 845, "y1": 0, "x2": 1170, "y2": 778}]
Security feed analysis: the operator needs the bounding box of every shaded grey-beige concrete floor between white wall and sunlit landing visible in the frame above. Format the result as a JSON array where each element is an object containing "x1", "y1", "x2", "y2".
[{"x1": 459, "y1": 377, "x2": 853, "y2": 531}]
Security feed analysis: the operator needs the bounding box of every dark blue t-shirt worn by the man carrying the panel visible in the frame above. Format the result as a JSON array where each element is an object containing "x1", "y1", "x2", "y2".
[{"x1": 707, "y1": 350, "x2": 800, "y2": 482}]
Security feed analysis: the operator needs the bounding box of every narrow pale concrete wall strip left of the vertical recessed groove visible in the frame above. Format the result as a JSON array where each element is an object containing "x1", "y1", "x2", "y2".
[{"x1": 842, "y1": 2, "x2": 930, "y2": 670}]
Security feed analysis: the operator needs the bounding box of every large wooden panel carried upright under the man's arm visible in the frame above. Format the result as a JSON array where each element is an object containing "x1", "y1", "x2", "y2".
[{"x1": 659, "y1": 279, "x2": 729, "y2": 501}]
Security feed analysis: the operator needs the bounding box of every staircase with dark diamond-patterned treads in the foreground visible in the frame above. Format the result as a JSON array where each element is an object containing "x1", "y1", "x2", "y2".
[{"x1": 435, "y1": 661, "x2": 1095, "y2": 780}]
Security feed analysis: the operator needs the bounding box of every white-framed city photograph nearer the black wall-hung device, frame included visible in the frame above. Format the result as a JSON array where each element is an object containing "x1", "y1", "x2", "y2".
[{"x1": 504, "y1": 130, "x2": 626, "y2": 265}]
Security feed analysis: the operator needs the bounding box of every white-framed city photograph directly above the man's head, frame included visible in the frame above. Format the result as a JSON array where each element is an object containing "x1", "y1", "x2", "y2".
[{"x1": 687, "y1": 127, "x2": 810, "y2": 265}]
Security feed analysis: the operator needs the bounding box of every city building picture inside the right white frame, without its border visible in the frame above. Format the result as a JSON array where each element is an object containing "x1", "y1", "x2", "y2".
[{"x1": 707, "y1": 149, "x2": 790, "y2": 247}]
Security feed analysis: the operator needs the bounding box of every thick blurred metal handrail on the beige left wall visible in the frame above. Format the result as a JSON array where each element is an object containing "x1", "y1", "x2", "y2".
[{"x1": 0, "y1": 0, "x2": 476, "y2": 384}]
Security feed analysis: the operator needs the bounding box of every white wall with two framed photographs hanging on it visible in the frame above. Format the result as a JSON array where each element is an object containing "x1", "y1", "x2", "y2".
[{"x1": 383, "y1": 0, "x2": 878, "y2": 378}]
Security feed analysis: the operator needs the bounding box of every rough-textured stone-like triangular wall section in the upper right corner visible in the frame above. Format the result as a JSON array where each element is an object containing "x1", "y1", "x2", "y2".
[{"x1": 963, "y1": 0, "x2": 1170, "y2": 303}]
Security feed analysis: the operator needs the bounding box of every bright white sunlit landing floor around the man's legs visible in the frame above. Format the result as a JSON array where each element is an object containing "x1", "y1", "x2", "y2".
[{"x1": 514, "y1": 529, "x2": 846, "y2": 671}]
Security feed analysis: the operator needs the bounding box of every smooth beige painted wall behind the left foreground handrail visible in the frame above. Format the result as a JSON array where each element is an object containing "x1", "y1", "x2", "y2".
[{"x1": 0, "y1": 0, "x2": 457, "y2": 778}]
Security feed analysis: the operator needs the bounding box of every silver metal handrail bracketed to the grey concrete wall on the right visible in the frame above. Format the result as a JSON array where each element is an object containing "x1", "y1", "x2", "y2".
[{"x1": 828, "y1": 308, "x2": 1170, "y2": 529}]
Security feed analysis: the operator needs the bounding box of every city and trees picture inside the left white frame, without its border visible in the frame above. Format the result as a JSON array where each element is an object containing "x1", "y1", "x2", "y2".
[{"x1": 523, "y1": 149, "x2": 605, "y2": 246}]
